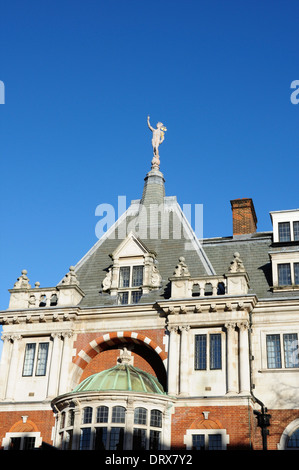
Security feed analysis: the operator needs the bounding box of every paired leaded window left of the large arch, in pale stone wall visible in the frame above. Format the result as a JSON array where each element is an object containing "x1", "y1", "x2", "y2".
[{"x1": 22, "y1": 343, "x2": 49, "y2": 377}]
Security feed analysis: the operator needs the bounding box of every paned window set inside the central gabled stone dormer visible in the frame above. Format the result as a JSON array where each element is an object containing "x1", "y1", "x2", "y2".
[{"x1": 118, "y1": 266, "x2": 143, "y2": 305}]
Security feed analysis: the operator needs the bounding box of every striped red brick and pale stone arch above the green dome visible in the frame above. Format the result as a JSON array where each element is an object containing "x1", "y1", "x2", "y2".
[{"x1": 74, "y1": 331, "x2": 167, "y2": 371}]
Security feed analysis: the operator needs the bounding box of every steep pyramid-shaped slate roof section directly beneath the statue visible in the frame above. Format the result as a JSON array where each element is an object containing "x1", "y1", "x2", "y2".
[{"x1": 75, "y1": 165, "x2": 215, "y2": 307}]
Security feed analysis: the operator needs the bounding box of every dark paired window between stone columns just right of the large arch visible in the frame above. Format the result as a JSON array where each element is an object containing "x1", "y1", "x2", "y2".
[{"x1": 194, "y1": 333, "x2": 222, "y2": 370}]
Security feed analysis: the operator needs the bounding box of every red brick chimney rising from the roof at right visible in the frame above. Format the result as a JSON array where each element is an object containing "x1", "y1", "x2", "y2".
[{"x1": 230, "y1": 198, "x2": 257, "y2": 235}]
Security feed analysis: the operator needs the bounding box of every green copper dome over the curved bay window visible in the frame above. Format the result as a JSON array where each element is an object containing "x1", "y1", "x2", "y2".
[{"x1": 73, "y1": 363, "x2": 165, "y2": 395}]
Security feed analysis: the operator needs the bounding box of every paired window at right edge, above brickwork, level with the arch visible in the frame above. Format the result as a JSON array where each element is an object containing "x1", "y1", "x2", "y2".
[{"x1": 266, "y1": 333, "x2": 299, "y2": 369}]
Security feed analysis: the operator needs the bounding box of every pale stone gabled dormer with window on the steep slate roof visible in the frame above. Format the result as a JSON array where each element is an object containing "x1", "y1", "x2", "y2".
[{"x1": 102, "y1": 232, "x2": 161, "y2": 305}]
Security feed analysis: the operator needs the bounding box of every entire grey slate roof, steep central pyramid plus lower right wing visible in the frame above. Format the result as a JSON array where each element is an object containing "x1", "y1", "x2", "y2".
[{"x1": 75, "y1": 166, "x2": 298, "y2": 307}]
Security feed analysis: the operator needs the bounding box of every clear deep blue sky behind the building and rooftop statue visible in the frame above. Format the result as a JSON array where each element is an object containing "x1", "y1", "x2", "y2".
[{"x1": 0, "y1": 0, "x2": 299, "y2": 354}]
